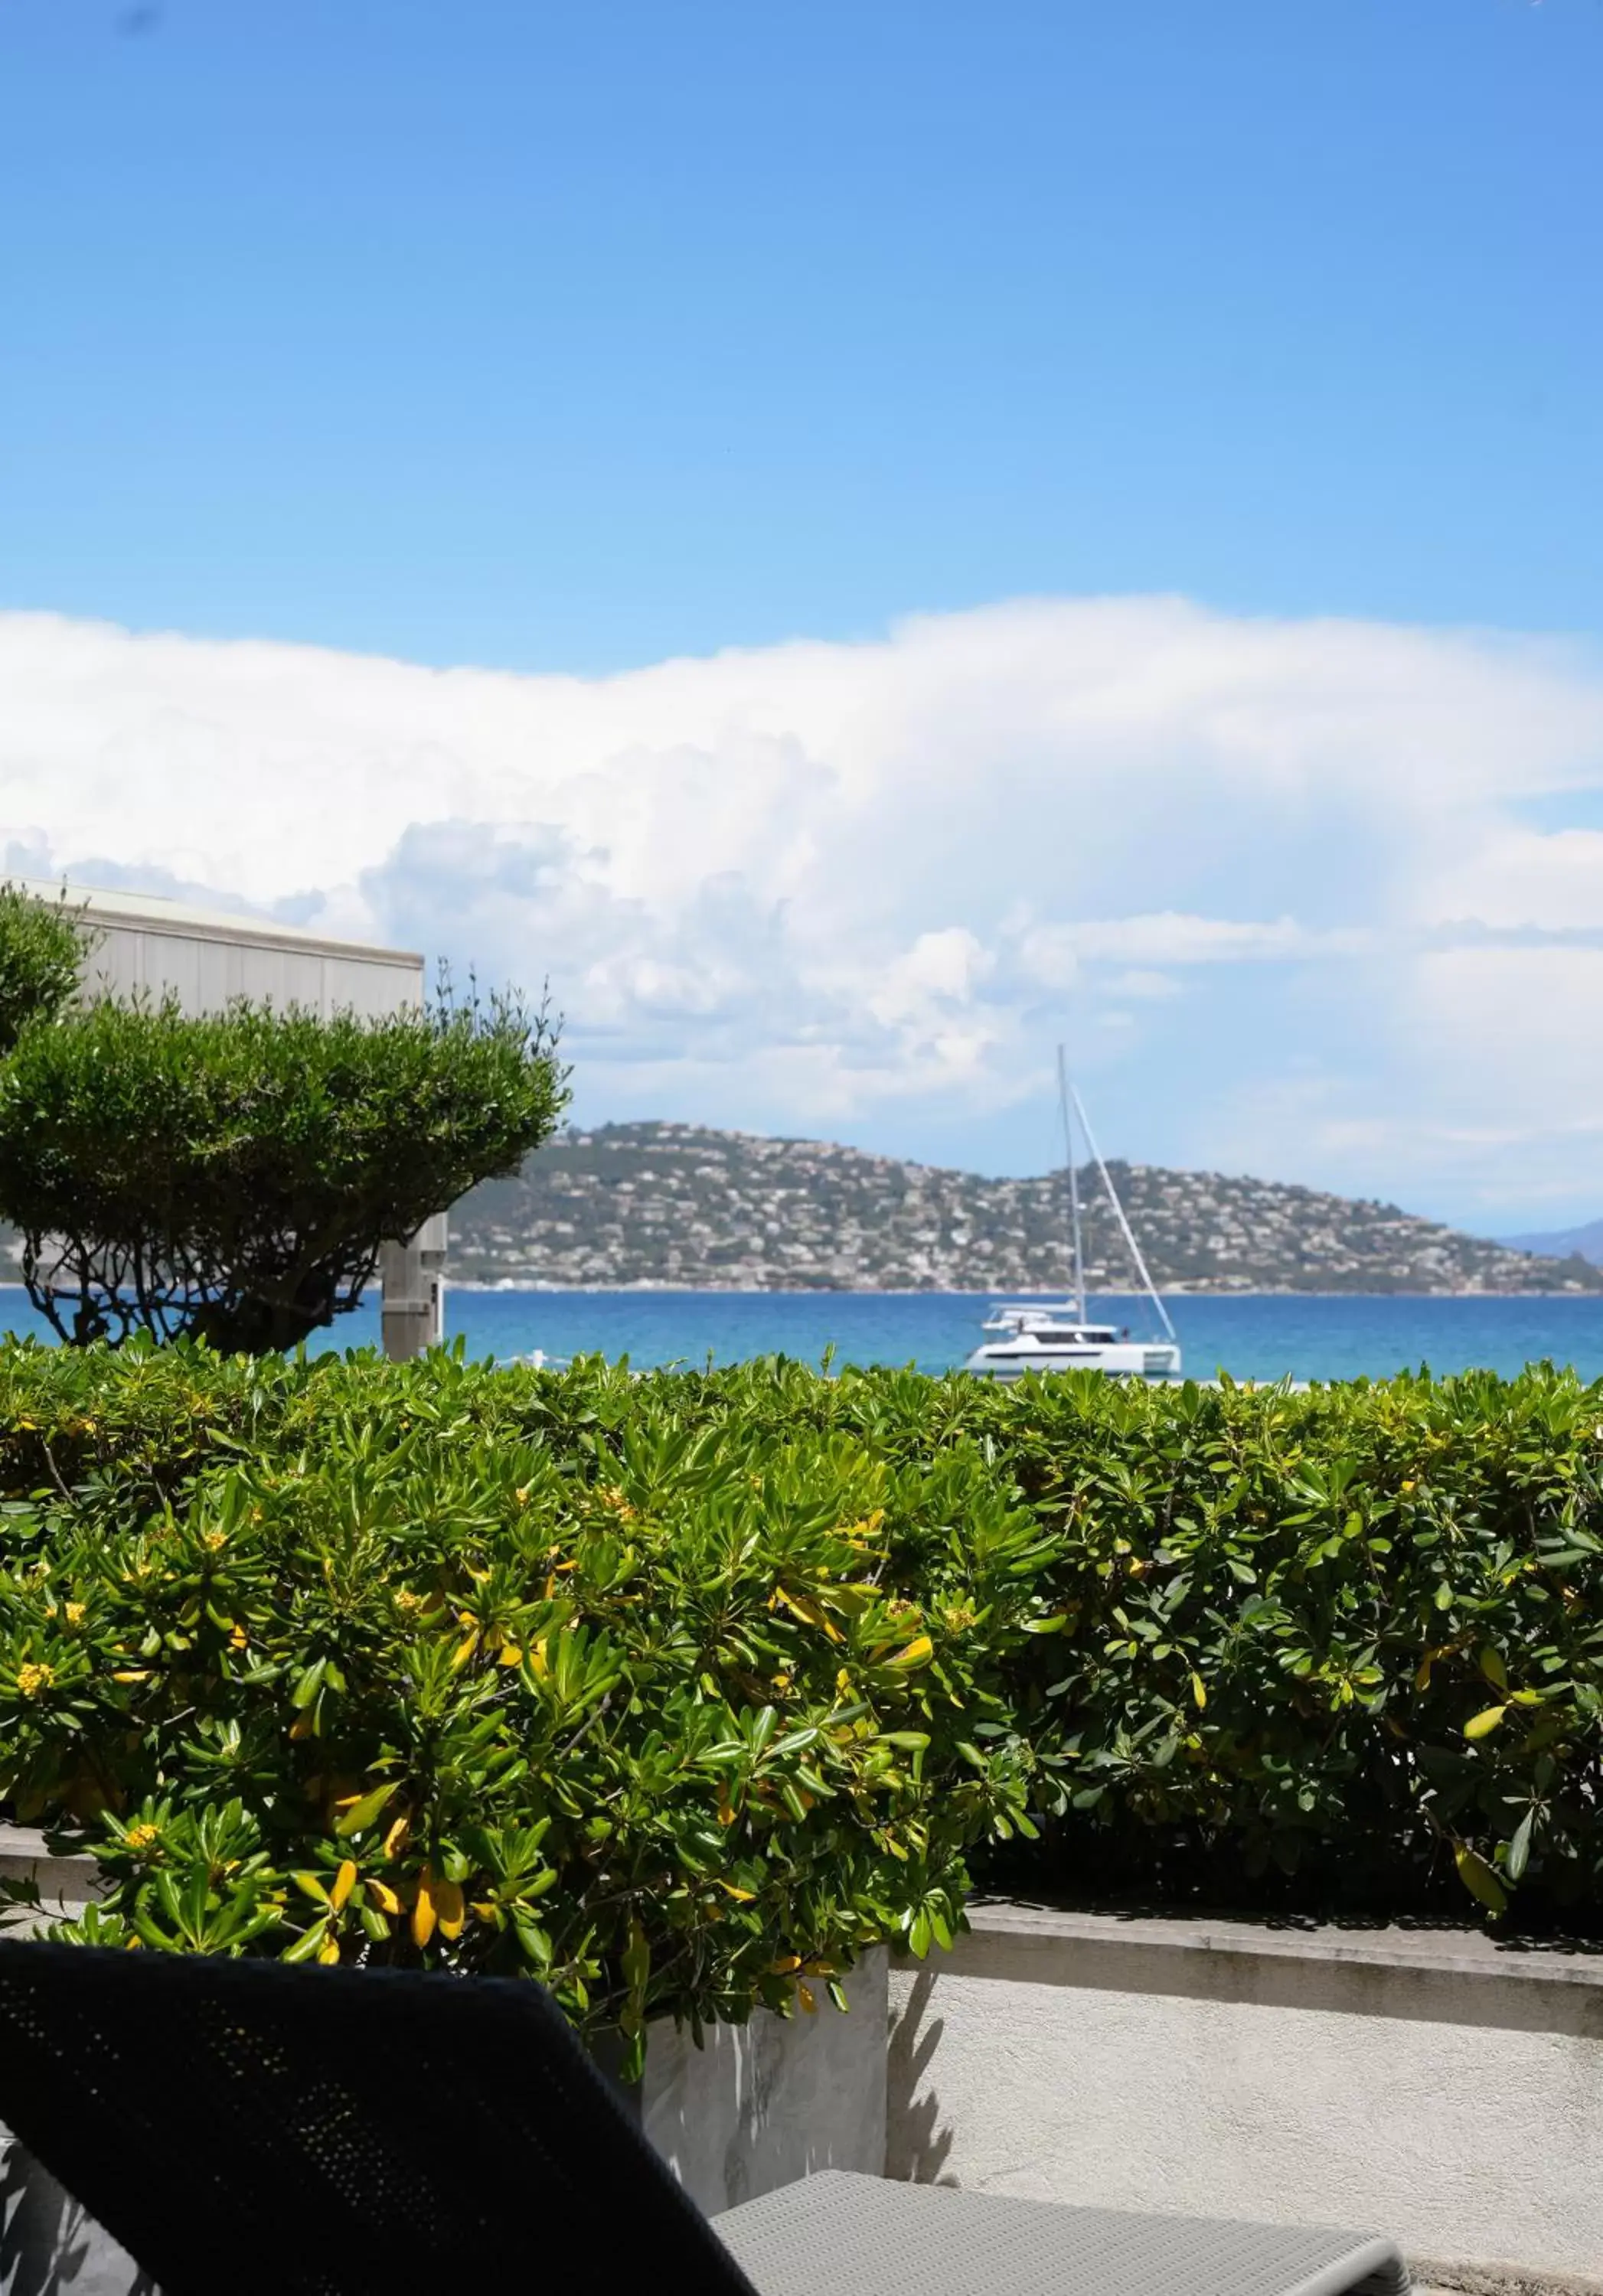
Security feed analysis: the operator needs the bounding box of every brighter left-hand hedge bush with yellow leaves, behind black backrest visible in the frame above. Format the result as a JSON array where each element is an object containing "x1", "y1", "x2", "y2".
[{"x1": 0, "y1": 1352, "x2": 1050, "y2": 2034}]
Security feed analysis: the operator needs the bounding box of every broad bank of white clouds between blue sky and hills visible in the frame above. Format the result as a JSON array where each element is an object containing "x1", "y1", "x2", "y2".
[{"x1": 0, "y1": 599, "x2": 1603, "y2": 1217}]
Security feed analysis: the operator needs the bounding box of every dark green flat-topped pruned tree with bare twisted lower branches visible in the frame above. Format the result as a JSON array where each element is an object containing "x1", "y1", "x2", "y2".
[{"x1": 0, "y1": 877, "x2": 567, "y2": 1355}]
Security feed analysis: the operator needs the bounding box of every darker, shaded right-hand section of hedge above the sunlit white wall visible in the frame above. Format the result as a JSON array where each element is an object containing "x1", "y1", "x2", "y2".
[{"x1": 988, "y1": 1371, "x2": 1603, "y2": 1922}]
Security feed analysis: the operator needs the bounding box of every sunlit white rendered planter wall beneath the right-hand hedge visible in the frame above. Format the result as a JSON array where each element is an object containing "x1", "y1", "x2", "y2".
[{"x1": 886, "y1": 1906, "x2": 1603, "y2": 2289}]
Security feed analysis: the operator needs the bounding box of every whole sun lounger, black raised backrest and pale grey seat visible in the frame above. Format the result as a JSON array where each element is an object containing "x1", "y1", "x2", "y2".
[{"x1": 0, "y1": 1940, "x2": 1408, "y2": 2296}]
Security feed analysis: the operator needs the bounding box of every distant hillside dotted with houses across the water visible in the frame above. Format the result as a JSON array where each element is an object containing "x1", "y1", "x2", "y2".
[{"x1": 448, "y1": 1123, "x2": 1603, "y2": 1293}]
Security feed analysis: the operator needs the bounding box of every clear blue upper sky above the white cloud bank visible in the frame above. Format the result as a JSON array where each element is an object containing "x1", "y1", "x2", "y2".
[{"x1": 0, "y1": 0, "x2": 1603, "y2": 668}]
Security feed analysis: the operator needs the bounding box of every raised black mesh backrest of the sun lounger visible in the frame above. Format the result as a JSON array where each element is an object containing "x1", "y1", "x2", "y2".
[{"x1": 0, "y1": 1940, "x2": 753, "y2": 2296}]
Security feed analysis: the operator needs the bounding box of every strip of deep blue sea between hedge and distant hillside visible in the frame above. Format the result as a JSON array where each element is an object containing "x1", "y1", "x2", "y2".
[{"x1": 0, "y1": 1286, "x2": 1603, "y2": 1380}]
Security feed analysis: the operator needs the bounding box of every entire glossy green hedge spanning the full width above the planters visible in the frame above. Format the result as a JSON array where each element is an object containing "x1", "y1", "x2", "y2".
[{"x1": 0, "y1": 1345, "x2": 1603, "y2": 2032}]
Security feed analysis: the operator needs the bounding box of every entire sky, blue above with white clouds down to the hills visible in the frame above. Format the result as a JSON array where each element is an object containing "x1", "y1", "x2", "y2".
[{"x1": 0, "y1": 0, "x2": 1603, "y2": 1226}]
